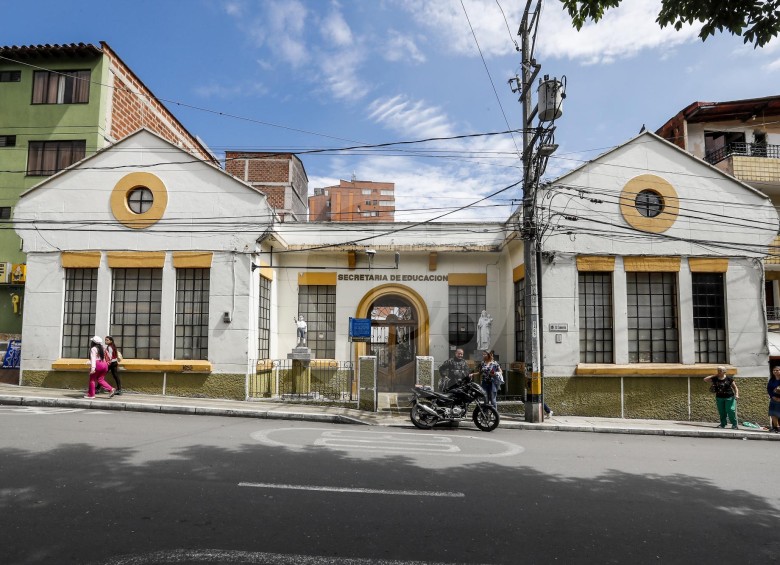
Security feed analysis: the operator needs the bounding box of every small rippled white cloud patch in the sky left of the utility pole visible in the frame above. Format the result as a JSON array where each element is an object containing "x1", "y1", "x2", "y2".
[{"x1": 368, "y1": 95, "x2": 453, "y2": 138}]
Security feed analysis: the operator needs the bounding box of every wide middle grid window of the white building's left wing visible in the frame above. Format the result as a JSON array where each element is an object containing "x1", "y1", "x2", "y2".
[{"x1": 111, "y1": 269, "x2": 162, "y2": 359}]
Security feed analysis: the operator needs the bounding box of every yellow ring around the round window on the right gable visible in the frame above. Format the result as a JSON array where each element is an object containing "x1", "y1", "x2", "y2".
[{"x1": 620, "y1": 175, "x2": 680, "y2": 233}]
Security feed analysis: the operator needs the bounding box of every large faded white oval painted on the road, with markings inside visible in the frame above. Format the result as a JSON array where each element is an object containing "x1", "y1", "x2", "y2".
[{"x1": 250, "y1": 428, "x2": 525, "y2": 460}]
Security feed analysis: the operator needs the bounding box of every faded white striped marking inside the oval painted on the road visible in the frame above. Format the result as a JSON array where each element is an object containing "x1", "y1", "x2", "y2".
[{"x1": 314, "y1": 431, "x2": 460, "y2": 453}]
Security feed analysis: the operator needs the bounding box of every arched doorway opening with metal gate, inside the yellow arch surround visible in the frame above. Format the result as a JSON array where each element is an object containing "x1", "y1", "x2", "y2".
[{"x1": 368, "y1": 294, "x2": 418, "y2": 392}]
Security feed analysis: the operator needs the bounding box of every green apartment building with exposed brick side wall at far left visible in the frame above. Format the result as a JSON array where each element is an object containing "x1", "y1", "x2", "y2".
[{"x1": 0, "y1": 42, "x2": 216, "y2": 340}]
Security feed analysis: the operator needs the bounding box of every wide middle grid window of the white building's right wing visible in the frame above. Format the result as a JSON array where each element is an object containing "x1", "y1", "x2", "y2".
[{"x1": 626, "y1": 272, "x2": 680, "y2": 363}]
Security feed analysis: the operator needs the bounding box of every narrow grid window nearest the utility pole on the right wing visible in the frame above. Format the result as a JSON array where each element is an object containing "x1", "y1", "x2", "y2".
[{"x1": 578, "y1": 272, "x2": 613, "y2": 363}]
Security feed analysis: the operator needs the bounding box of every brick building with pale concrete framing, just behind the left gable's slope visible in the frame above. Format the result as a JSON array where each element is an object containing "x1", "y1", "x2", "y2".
[{"x1": 225, "y1": 151, "x2": 309, "y2": 222}]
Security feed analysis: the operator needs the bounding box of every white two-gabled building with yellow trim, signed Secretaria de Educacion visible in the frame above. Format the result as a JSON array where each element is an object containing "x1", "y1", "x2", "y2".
[{"x1": 15, "y1": 131, "x2": 778, "y2": 419}]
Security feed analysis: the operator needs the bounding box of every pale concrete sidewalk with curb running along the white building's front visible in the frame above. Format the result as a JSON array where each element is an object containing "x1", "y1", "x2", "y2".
[{"x1": 0, "y1": 383, "x2": 780, "y2": 441}]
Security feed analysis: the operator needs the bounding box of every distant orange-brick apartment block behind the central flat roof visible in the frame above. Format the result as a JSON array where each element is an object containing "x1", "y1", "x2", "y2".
[{"x1": 309, "y1": 179, "x2": 395, "y2": 222}]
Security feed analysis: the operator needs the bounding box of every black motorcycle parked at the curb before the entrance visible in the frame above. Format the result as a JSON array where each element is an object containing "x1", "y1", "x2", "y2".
[{"x1": 409, "y1": 377, "x2": 500, "y2": 432}]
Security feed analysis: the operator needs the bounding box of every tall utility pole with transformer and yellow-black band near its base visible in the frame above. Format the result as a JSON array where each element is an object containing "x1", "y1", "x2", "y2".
[{"x1": 509, "y1": 0, "x2": 564, "y2": 422}]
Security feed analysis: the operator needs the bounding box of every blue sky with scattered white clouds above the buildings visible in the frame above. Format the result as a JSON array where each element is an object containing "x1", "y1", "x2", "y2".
[{"x1": 0, "y1": 0, "x2": 780, "y2": 221}]
